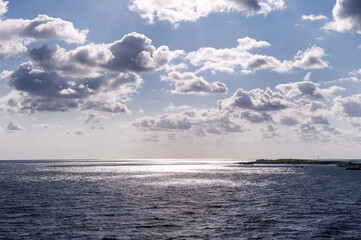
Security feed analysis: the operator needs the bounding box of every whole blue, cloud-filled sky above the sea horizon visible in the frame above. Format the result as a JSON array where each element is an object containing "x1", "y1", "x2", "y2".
[{"x1": 0, "y1": 0, "x2": 361, "y2": 160}]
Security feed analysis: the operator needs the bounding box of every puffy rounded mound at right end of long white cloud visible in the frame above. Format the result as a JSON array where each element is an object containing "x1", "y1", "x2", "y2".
[{"x1": 293, "y1": 45, "x2": 329, "y2": 69}]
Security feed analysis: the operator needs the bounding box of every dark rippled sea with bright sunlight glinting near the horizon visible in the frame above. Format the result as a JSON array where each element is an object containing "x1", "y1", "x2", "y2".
[{"x1": 0, "y1": 160, "x2": 361, "y2": 239}]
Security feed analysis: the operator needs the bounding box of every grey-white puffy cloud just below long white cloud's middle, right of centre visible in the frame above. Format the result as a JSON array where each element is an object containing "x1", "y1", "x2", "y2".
[{"x1": 218, "y1": 88, "x2": 289, "y2": 111}]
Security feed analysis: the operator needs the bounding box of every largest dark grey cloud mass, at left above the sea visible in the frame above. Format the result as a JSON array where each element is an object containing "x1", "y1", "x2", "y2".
[{"x1": 0, "y1": 33, "x2": 181, "y2": 114}]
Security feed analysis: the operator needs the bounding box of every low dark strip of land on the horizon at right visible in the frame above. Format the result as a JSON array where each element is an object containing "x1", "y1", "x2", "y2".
[{"x1": 238, "y1": 158, "x2": 361, "y2": 170}]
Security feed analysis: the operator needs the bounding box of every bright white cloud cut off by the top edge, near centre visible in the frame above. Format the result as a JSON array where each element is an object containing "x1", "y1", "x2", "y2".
[{"x1": 129, "y1": 0, "x2": 285, "y2": 26}]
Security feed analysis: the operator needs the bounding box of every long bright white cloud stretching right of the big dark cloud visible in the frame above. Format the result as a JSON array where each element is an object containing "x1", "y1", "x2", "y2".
[{"x1": 186, "y1": 37, "x2": 329, "y2": 73}]
